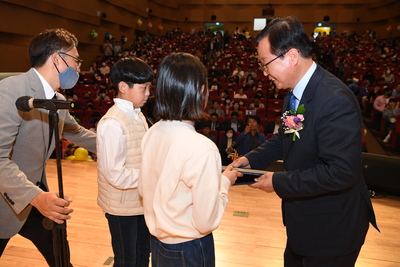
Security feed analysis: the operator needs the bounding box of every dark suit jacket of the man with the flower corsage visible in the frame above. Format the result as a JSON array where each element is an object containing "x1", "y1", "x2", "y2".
[{"x1": 245, "y1": 66, "x2": 377, "y2": 257}]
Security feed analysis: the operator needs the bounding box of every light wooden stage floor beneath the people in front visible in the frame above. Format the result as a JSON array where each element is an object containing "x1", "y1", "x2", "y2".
[{"x1": 0, "y1": 160, "x2": 400, "y2": 267}]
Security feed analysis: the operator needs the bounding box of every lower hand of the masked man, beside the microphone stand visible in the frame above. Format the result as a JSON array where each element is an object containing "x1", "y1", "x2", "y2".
[{"x1": 30, "y1": 192, "x2": 74, "y2": 224}]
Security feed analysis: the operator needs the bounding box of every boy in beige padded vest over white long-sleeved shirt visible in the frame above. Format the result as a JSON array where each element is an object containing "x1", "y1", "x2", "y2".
[{"x1": 97, "y1": 58, "x2": 153, "y2": 267}]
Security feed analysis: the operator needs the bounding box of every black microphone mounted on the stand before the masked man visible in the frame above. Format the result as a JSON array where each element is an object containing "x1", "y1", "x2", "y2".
[{"x1": 15, "y1": 96, "x2": 74, "y2": 111}]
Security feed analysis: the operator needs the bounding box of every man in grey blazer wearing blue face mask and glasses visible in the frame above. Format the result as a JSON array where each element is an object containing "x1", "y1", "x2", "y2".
[{"x1": 0, "y1": 29, "x2": 96, "y2": 266}]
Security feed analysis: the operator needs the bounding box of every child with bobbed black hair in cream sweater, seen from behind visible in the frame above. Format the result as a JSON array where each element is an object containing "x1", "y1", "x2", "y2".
[{"x1": 139, "y1": 53, "x2": 241, "y2": 267}]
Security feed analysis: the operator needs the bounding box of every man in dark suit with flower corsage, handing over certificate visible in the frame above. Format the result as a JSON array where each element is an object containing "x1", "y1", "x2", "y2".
[{"x1": 232, "y1": 17, "x2": 377, "y2": 267}]
